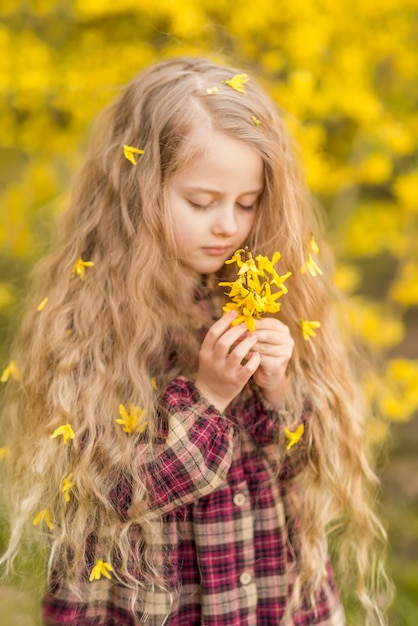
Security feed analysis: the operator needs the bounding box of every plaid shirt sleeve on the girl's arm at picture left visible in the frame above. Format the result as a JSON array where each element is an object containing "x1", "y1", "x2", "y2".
[{"x1": 112, "y1": 377, "x2": 234, "y2": 521}]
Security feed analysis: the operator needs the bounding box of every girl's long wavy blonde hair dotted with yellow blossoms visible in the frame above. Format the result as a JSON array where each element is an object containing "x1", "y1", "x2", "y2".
[{"x1": 2, "y1": 58, "x2": 386, "y2": 624}]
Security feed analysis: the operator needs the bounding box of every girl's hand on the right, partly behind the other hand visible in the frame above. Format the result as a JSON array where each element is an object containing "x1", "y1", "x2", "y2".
[{"x1": 253, "y1": 317, "x2": 295, "y2": 409}]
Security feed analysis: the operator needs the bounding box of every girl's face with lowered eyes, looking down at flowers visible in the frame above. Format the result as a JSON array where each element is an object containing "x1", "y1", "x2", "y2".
[{"x1": 167, "y1": 124, "x2": 264, "y2": 274}]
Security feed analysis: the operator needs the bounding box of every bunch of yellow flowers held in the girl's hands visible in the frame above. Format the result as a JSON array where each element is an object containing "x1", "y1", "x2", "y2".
[{"x1": 219, "y1": 248, "x2": 291, "y2": 332}]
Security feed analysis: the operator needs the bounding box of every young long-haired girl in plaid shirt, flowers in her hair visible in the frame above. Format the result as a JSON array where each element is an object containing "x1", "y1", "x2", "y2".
[{"x1": 2, "y1": 58, "x2": 385, "y2": 626}]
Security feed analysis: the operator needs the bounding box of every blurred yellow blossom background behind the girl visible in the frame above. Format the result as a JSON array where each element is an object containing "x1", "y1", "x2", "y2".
[{"x1": 0, "y1": 0, "x2": 418, "y2": 626}]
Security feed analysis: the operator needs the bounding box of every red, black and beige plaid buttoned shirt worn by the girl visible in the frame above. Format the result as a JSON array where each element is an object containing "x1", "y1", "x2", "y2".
[{"x1": 43, "y1": 377, "x2": 345, "y2": 626}]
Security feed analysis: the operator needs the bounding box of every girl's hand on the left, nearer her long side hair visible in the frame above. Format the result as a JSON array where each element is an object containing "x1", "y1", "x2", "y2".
[{"x1": 195, "y1": 311, "x2": 260, "y2": 412}]
